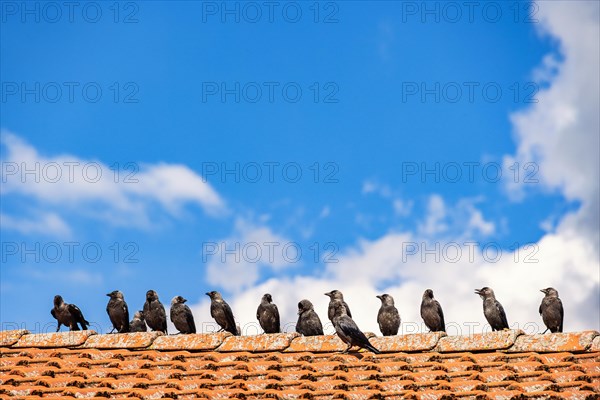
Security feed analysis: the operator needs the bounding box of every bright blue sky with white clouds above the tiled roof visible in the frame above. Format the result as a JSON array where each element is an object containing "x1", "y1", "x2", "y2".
[{"x1": 0, "y1": 1, "x2": 600, "y2": 330}]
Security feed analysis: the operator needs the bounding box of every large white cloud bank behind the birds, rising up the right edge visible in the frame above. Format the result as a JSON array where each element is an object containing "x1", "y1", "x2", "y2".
[{"x1": 196, "y1": 1, "x2": 600, "y2": 334}]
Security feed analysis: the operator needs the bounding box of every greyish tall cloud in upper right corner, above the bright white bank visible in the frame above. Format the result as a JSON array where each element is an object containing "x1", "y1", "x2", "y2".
[{"x1": 504, "y1": 1, "x2": 600, "y2": 240}]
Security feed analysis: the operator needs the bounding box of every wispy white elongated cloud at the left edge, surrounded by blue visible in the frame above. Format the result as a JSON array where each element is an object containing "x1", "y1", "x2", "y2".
[{"x1": 0, "y1": 132, "x2": 226, "y2": 232}]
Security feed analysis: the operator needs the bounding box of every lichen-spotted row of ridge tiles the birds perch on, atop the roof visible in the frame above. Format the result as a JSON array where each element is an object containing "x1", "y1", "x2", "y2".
[{"x1": 0, "y1": 329, "x2": 600, "y2": 353}]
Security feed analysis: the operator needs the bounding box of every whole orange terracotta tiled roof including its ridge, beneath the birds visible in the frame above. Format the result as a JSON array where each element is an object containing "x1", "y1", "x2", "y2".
[{"x1": 0, "y1": 330, "x2": 600, "y2": 399}]
